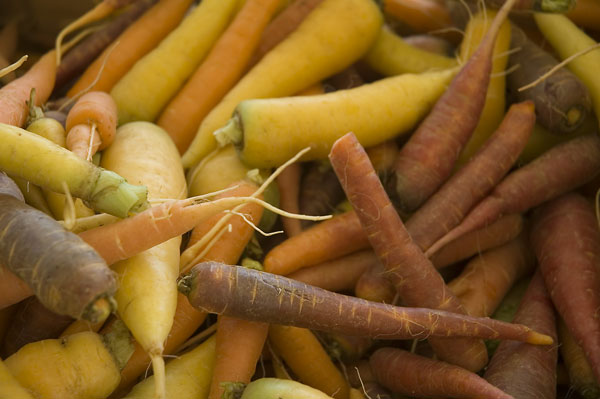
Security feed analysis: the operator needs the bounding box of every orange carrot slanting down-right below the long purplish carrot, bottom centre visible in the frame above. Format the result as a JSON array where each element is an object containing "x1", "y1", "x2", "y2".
[{"x1": 269, "y1": 325, "x2": 350, "y2": 399}]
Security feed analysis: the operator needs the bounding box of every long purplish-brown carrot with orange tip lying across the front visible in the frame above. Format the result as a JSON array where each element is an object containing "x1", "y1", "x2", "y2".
[{"x1": 179, "y1": 262, "x2": 553, "y2": 345}]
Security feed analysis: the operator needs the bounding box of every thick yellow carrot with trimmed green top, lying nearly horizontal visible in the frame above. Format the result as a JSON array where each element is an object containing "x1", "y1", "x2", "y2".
[{"x1": 214, "y1": 68, "x2": 456, "y2": 168}]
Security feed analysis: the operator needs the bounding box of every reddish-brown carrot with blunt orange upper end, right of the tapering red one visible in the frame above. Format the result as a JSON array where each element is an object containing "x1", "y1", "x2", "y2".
[{"x1": 406, "y1": 101, "x2": 535, "y2": 250}]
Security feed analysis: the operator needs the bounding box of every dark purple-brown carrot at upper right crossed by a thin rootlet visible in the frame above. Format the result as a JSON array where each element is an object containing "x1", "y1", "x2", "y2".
[{"x1": 507, "y1": 25, "x2": 592, "y2": 134}]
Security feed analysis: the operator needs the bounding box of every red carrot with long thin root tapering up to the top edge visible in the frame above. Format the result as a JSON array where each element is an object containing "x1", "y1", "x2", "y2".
[{"x1": 386, "y1": 0, "x2": 515, "y2": 212}]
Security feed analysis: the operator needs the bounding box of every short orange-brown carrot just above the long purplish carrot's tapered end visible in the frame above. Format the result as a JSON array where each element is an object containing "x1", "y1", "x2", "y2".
[{"x1": 448, "y1": 234, "x2": 535, "y2": 316}]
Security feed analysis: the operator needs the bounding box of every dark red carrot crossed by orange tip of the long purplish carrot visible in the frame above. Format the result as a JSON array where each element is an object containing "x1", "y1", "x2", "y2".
[{"x1": 484, "y1": 270, "x2": 558, "y2": 399}]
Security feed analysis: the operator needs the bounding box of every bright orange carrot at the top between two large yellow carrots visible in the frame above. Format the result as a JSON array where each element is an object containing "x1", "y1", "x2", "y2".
[{"x1": 157, "y1": 0, "x2": 279, "y2": 154}]
